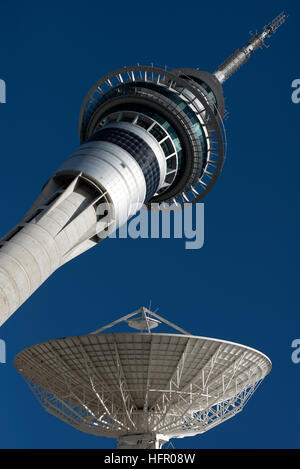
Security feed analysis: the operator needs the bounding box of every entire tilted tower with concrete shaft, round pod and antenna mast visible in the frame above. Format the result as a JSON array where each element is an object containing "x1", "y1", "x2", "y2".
[{"x1": 0, "y1": 13, "x2": 286, "y2": 325}]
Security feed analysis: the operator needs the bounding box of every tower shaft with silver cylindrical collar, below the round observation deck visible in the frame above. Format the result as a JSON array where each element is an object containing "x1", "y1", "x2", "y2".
[{"x1": 0, "y1": 119, "x2": 166, "y2": 325}]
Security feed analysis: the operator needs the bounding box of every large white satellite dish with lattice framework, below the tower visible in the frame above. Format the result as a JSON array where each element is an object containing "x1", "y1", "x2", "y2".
[{"x1": 15, "y1": 307, "x2": 271, "y2": 449}]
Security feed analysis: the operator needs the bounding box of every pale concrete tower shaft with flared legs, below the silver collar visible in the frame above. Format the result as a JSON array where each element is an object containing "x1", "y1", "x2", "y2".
[{"x1": 0, "y1": 177, "x2": 97, "y2": 324}]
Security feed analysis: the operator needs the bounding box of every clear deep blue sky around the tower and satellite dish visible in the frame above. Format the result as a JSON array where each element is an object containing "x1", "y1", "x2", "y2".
[{"x1": 0, "y1": 0, "x2": 300, "y2": 448}]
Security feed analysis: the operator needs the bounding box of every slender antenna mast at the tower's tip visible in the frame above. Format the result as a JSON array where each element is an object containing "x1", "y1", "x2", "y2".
[{"x1": 214, "y1": 12, "x2": 287, "y2": 83}]
